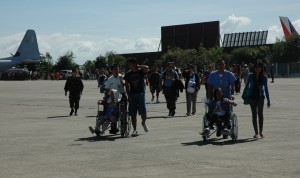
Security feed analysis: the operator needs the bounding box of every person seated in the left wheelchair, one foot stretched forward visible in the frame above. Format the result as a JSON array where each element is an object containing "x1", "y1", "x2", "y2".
[{"x1": 89, "y1": 89, "x2": 119, "y2": 134}]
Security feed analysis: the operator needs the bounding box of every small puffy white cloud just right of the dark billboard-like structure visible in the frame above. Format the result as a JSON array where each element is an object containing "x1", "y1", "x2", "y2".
[{"x1": 220, "y1": 14, "x2": 251, "y2": 34}]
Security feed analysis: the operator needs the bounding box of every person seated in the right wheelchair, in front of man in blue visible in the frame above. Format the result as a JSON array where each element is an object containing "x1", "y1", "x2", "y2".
[{"x1": 204, "y1": 88, "x2": 236, "y2": 137}]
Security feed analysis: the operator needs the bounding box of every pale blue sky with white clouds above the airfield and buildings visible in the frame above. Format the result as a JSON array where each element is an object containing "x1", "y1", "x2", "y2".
[{"x1": 0, "y1": 0, "x2": 300, "y2": 64}]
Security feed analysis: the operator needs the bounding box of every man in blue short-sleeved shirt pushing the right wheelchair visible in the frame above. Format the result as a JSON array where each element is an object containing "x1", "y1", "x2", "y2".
[{"x1": 207, "y1": 59, "x2": 236, "y2": 100}]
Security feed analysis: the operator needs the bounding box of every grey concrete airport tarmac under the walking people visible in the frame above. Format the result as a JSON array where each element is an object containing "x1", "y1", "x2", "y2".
[{"x1": 0, "y1": 78, "x2": 300, "y2": 178}]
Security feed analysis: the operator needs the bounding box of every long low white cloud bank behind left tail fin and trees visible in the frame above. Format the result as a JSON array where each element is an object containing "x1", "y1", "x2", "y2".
[{"x1": 0, "y1": 33, "x2": 160, "y2": 64}]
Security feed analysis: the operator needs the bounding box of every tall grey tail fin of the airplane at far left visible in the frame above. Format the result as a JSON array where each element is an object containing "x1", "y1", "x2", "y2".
[{"x1": 14, "y1": 30, "x2": 40, "y2": 60}]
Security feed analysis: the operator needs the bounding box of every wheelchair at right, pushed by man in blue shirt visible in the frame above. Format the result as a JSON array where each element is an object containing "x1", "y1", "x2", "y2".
[{"x1": 200, "y1": 103, "x2": 238, "y2": 142}]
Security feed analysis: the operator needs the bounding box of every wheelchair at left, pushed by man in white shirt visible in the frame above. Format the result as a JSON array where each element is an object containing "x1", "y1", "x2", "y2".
[{"x1": 95, "y1": 95, "x2": 131, "y2": 138}]
